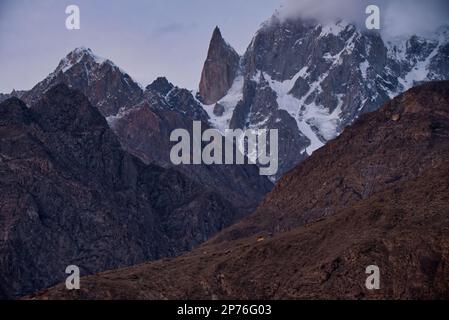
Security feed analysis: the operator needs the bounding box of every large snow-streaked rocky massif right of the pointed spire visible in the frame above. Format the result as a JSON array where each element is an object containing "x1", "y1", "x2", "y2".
[{"x1": 199, "y1": 15, "x2": 449, "y2": 176}]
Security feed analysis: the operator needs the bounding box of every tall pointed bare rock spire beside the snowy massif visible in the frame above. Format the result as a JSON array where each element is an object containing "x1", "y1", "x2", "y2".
[{"x1": 199, "y1": 27, "x2": 240, "y2": 105}]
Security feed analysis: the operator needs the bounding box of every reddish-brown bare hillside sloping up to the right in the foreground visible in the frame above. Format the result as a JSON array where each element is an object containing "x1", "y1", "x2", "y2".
[{"x1": 34, "y1": 82, "x2": 449, "y2": 300}]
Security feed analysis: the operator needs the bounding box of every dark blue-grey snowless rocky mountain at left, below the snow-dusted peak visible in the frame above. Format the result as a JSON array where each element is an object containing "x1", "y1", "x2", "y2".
[{"x1": 0, "y1": 85, "x2": 236, "y2": 298}]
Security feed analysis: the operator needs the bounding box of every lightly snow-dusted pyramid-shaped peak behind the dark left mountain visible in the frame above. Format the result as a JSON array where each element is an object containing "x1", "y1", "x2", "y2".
[{"x1": 21, "y1": 48, "x2": 143, "y2": 117}]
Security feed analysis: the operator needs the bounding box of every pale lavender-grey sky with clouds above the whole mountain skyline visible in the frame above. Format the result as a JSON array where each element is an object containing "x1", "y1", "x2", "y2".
[{"x1": 0, "y1": 0, "x2": 449, "y2": 92}]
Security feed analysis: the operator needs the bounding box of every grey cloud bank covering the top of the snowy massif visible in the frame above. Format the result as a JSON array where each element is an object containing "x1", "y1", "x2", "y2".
[{"x1": 278, "y1": 0, "x2": 449, "y2": 37}]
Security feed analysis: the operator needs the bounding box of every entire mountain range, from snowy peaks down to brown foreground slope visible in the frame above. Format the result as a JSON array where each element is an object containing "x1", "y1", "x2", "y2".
[{"x1": 0, "y1": 10, "x2": 449, "y2": 299}]
